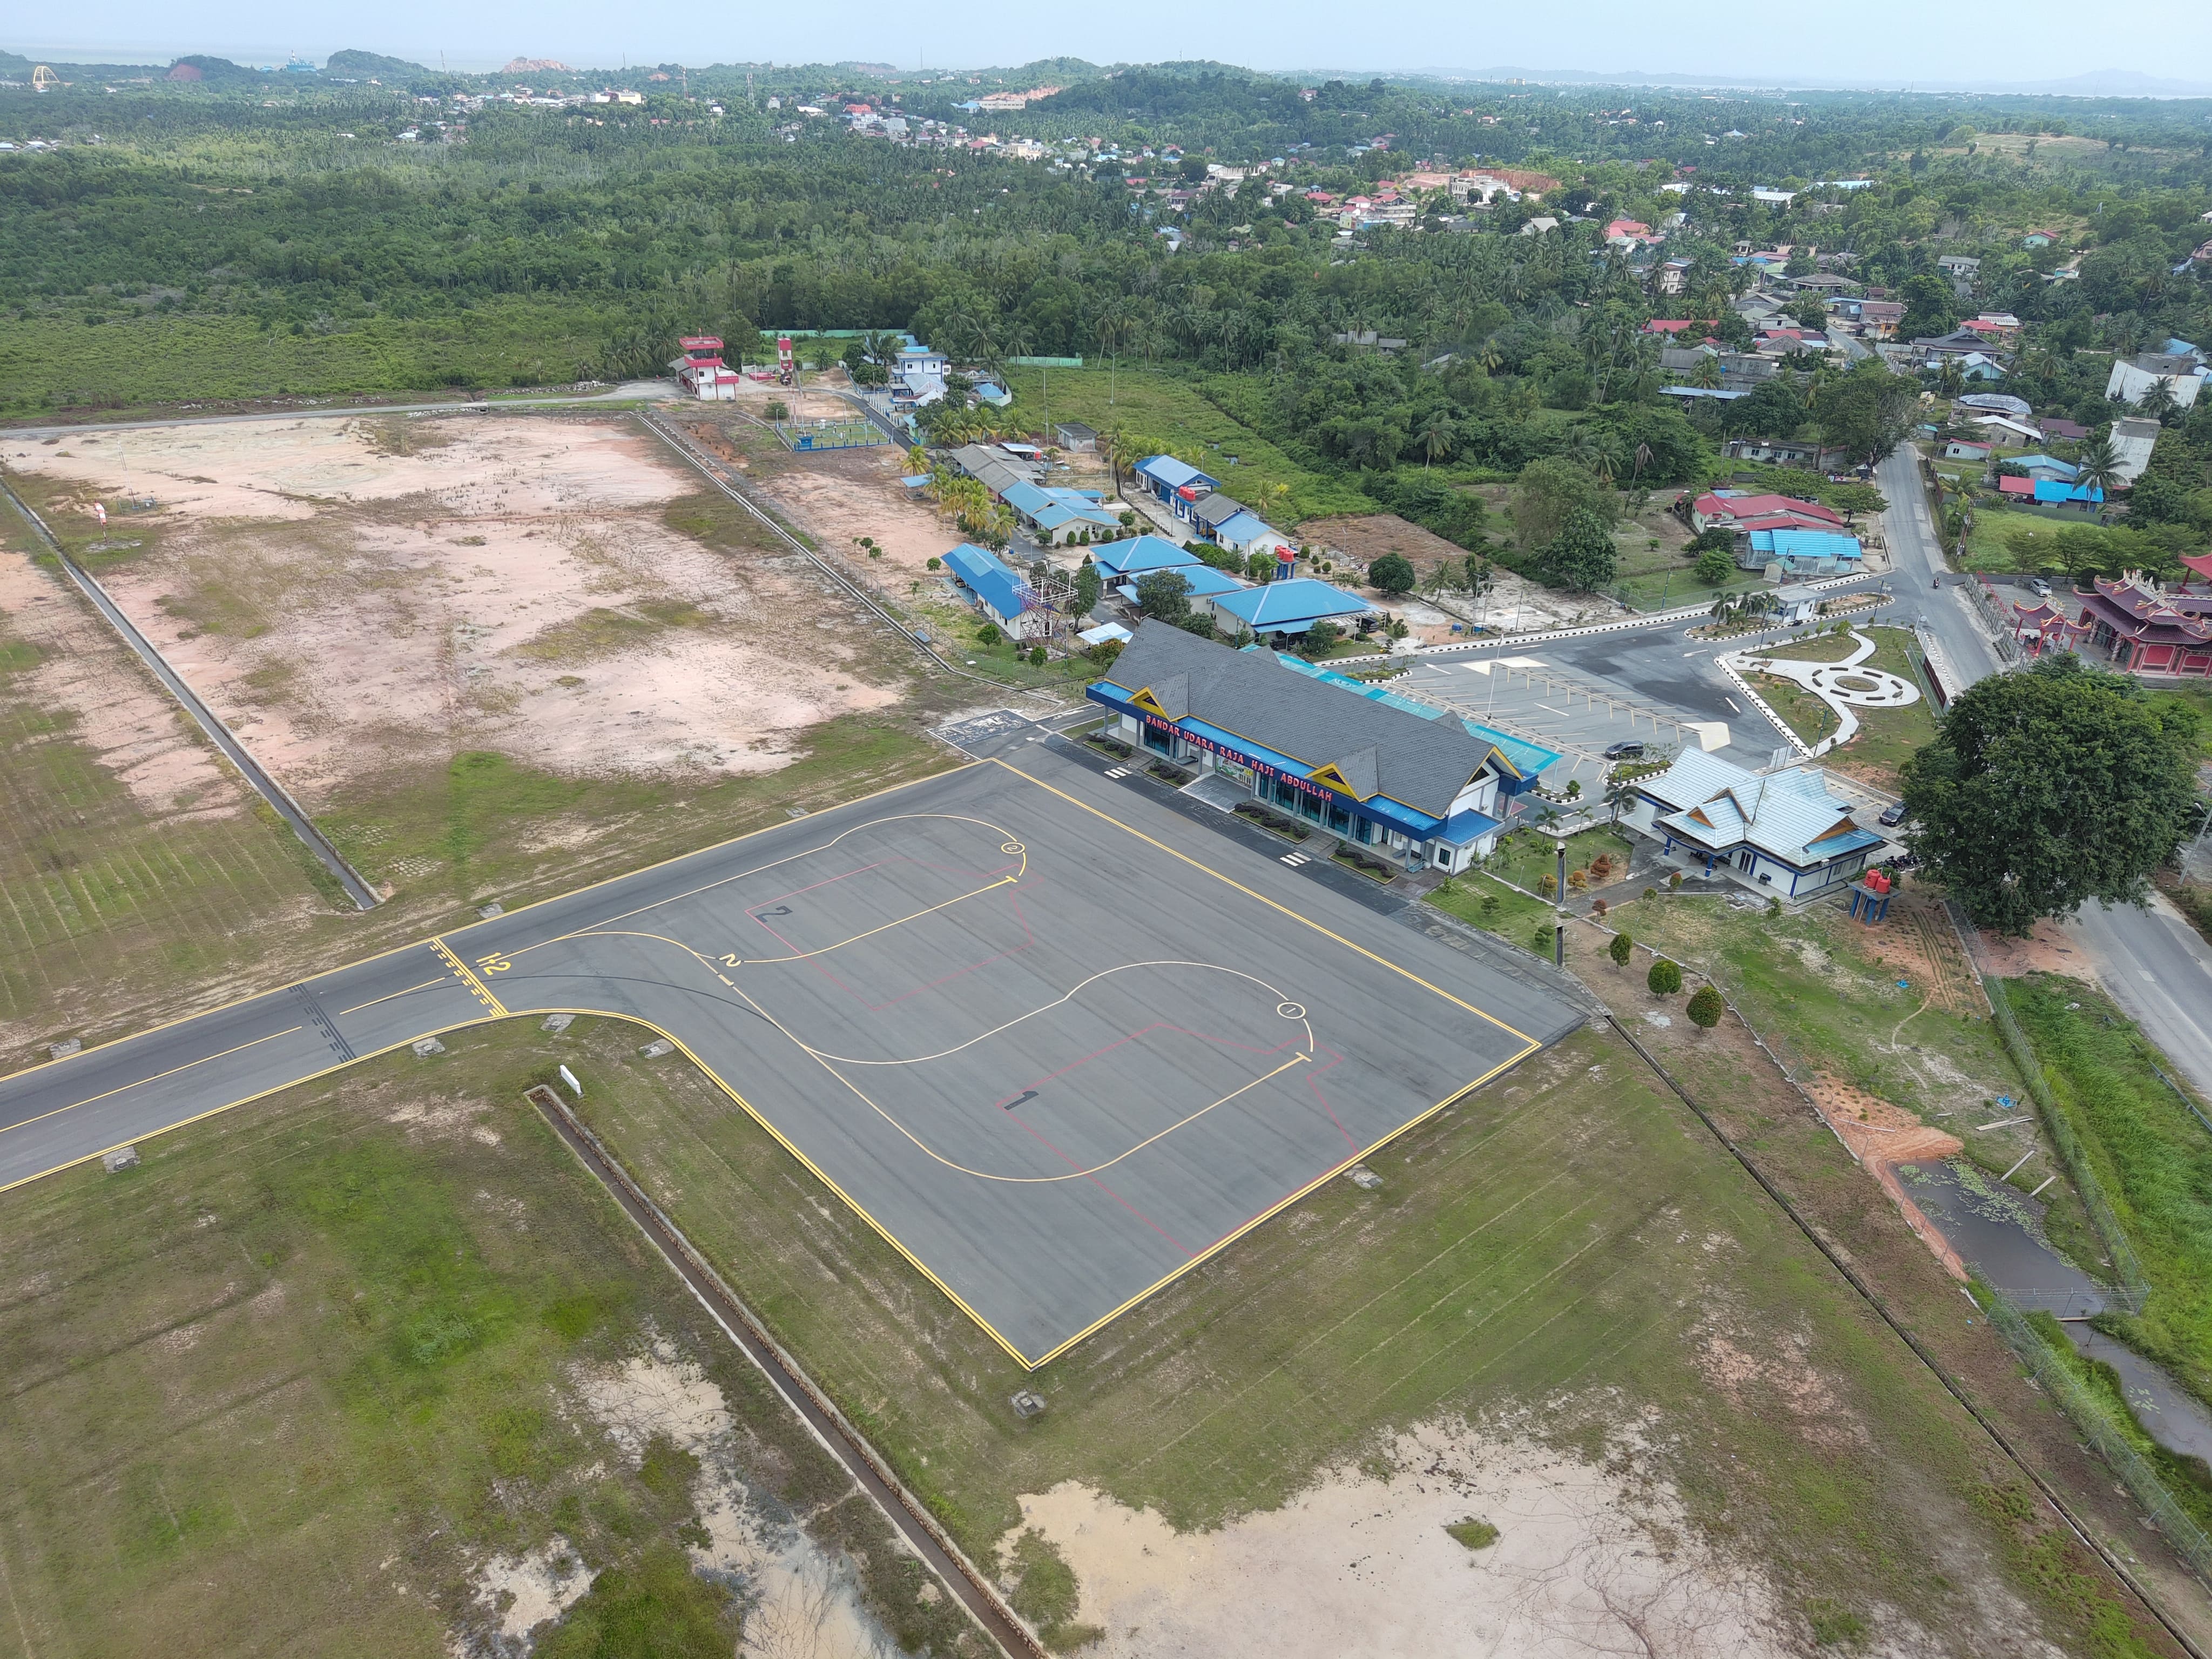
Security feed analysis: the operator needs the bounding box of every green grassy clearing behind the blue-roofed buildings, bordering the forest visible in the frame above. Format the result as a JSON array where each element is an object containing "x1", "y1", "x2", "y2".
[{"x1": 1009, "y1": 363, "x2": 1380, "y2": 531}]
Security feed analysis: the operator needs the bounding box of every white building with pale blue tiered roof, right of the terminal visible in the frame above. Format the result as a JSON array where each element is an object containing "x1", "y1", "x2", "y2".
[{"x1": 1621, "y1": 750, "x2": 1891, "y2": 902}]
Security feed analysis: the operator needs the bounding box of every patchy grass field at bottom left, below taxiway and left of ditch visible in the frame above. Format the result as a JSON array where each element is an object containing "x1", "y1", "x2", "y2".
[{"x1": 0, "y1": 1022, "x2": 987, "y2": 1659}]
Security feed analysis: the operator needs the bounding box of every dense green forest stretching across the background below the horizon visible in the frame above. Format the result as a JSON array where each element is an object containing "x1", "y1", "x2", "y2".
[{"x1": 0, "y1": 53, "x2": 2212, "y2": 579}]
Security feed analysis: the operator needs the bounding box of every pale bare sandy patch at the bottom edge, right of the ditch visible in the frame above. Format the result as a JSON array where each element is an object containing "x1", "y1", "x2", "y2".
[{"x1": 1009, "y1": 1425, "x2": 1800, "y2": 1659}]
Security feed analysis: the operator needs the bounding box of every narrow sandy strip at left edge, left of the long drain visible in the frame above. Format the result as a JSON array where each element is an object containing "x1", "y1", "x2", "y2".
[{"x1": 0, "y1": 551, "x2": 248, "y2": 819}]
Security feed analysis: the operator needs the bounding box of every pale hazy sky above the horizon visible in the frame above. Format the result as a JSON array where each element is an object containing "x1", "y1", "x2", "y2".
[{"x1": 30, "y1": 0, "x2": 2212, "y2": 86}]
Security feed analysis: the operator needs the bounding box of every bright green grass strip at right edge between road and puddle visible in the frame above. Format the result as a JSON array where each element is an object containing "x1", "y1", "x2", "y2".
[{"x1": 2006, "y1": 975, "x2": 2212, "y2": 1402}]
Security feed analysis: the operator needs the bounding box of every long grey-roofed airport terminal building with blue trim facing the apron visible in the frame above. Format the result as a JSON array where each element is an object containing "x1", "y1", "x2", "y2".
[{"x1": 1086, "y1": 622, "x2": 1560, "y2": 872}]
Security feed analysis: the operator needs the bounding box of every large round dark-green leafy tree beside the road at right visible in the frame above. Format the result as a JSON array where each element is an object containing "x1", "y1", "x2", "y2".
[{"x1": 1905, "y1": 657, "x2": 2194, "y2": 936}]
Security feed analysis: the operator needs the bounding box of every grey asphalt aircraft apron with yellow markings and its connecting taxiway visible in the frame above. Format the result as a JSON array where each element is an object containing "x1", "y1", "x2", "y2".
[{"x1": 0, "y1": 747, "x2": 1582, "y2": 1367}]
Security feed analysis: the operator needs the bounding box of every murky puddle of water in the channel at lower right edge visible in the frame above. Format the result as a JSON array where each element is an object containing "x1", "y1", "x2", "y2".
[{"x1": 1898, "y1": 1159, "x2": 2212, "y2": 1462}]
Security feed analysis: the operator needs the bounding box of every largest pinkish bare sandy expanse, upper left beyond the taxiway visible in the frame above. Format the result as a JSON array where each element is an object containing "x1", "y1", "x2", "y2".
[{"x1": 29, "y1": 416, "x2": 898, "y2": 803}]
